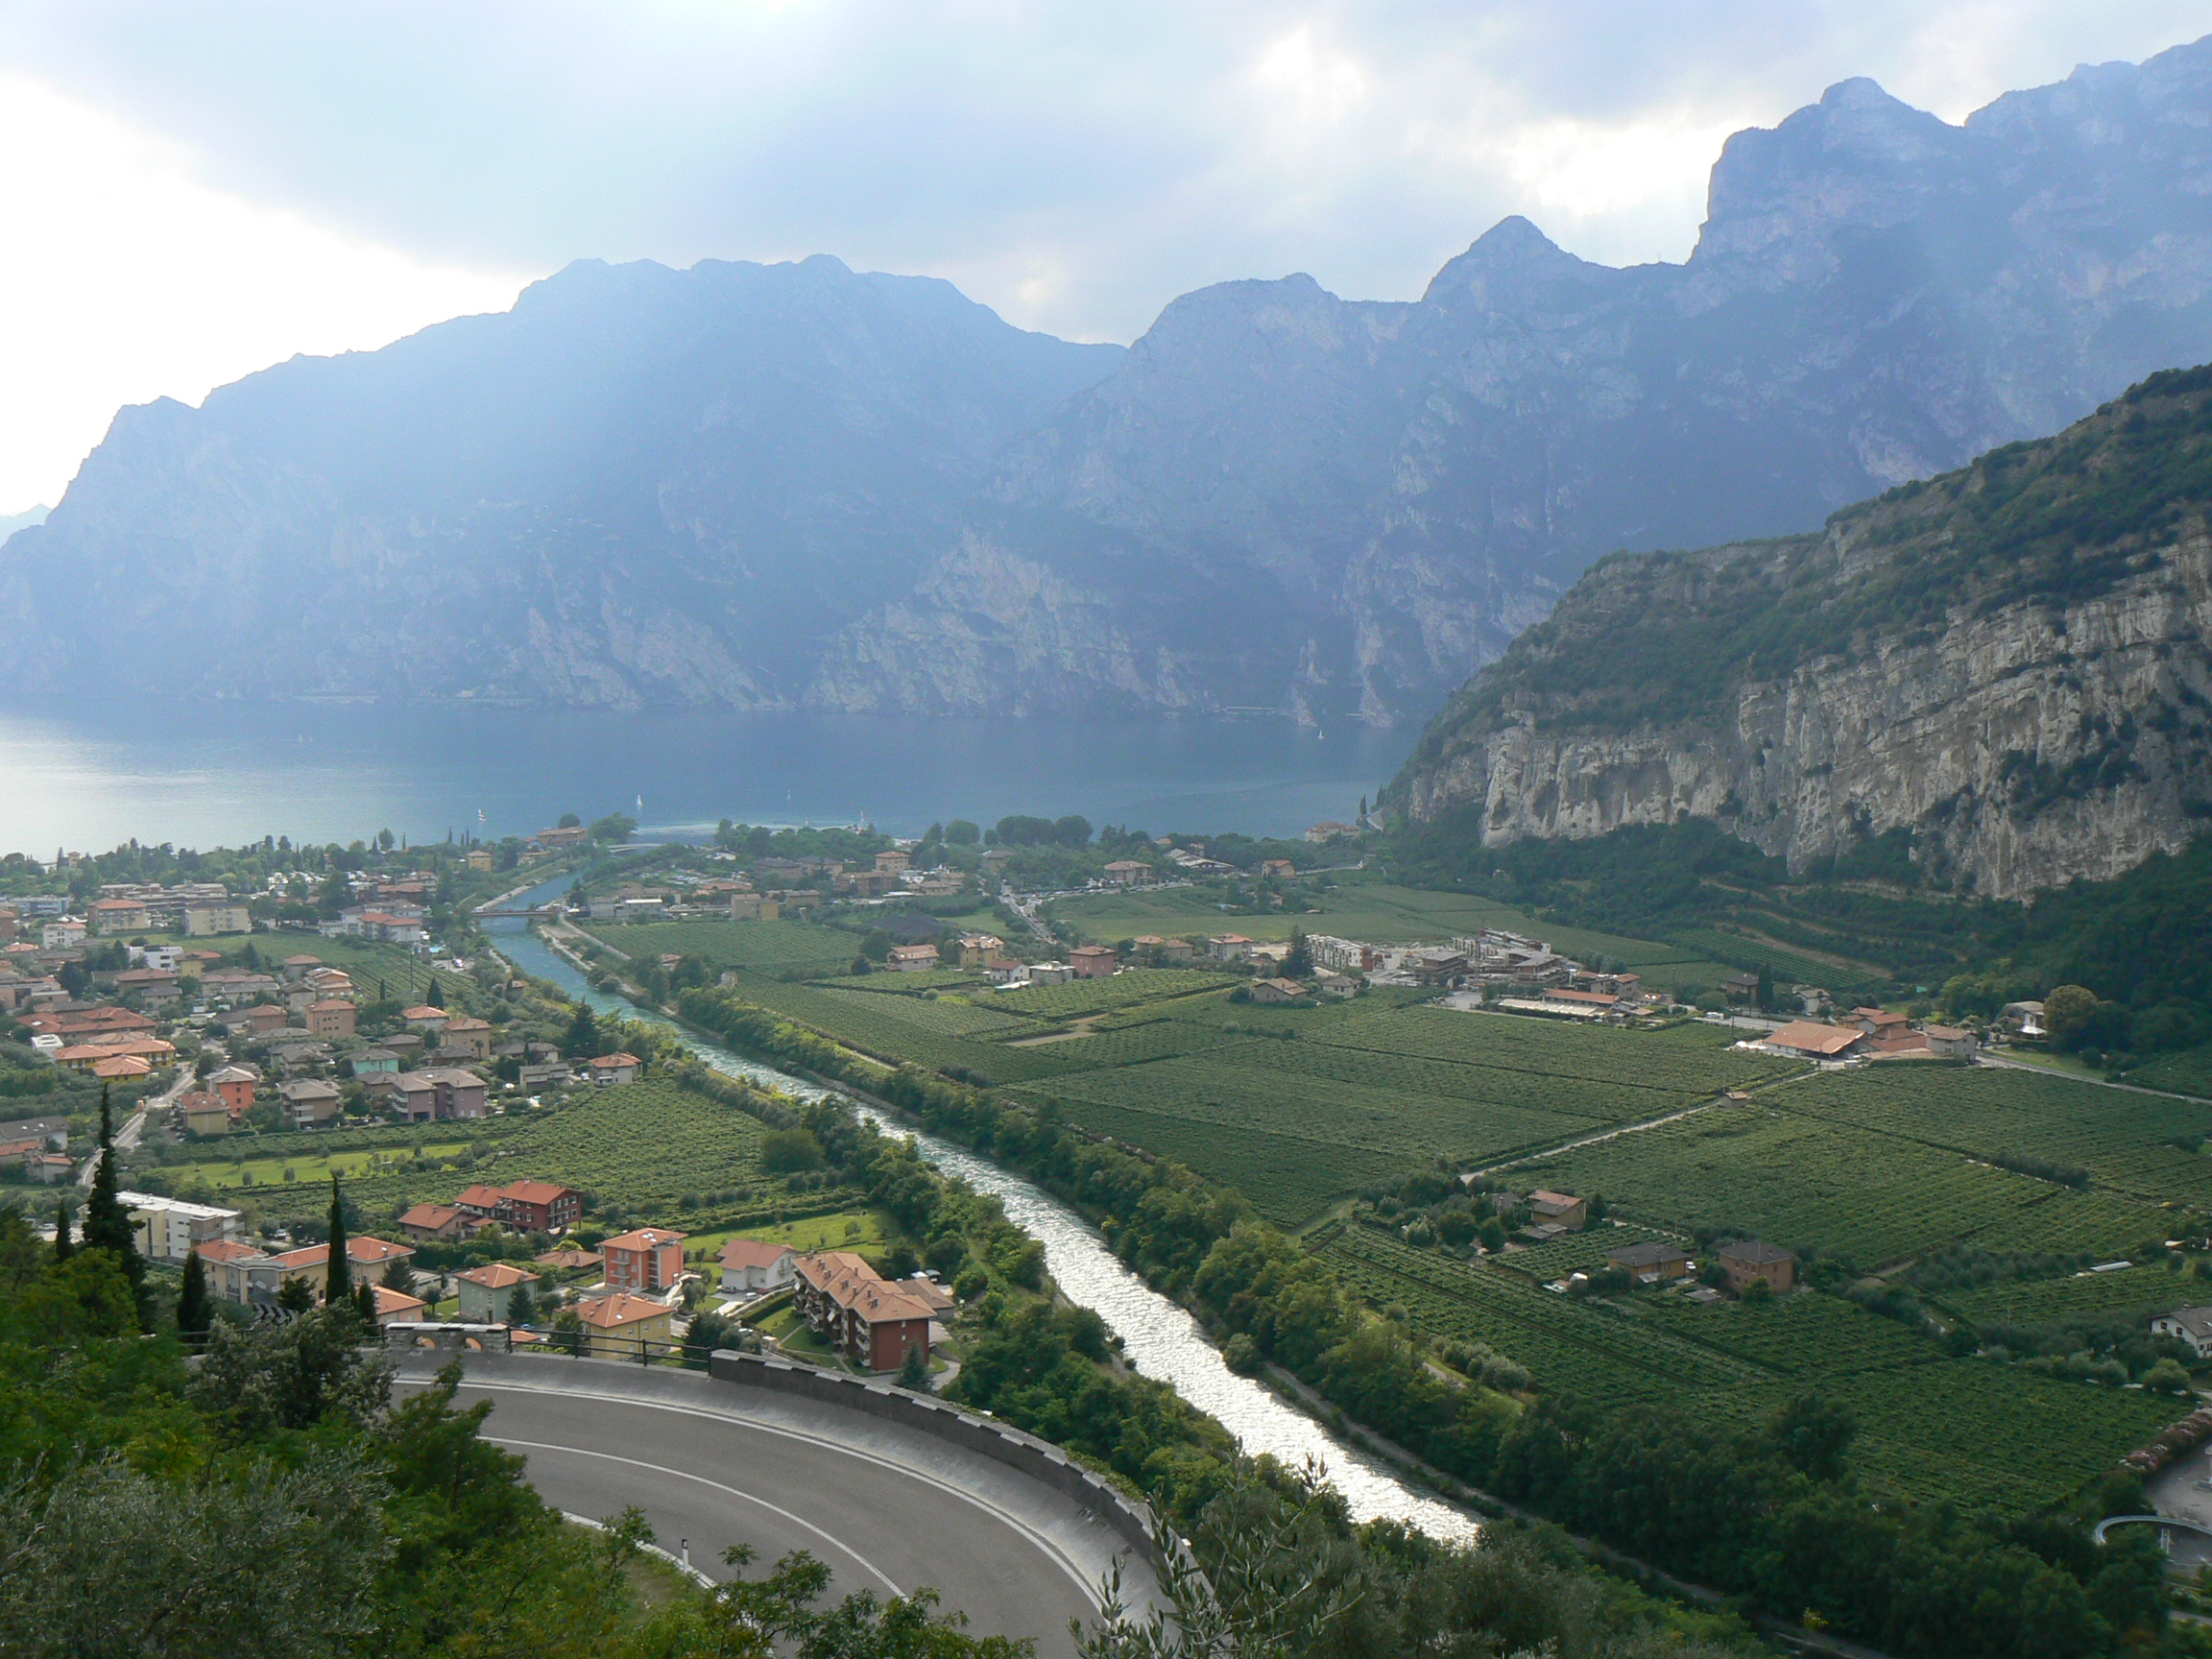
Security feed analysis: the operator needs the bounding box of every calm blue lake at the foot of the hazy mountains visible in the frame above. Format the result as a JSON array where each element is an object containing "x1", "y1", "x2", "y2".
[{"x1": 0, "y1": 699, "x2": 1416, "y2": 858}]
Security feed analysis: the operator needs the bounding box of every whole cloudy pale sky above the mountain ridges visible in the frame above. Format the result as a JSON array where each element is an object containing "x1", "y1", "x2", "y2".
[{"x1": 0, "y1": 0, "x2": 2212, "y2": 514}]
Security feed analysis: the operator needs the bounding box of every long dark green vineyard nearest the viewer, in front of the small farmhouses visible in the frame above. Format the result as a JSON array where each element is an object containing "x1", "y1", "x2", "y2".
[{"x1": 1323, "y1": 1228, "x2": 2181, "y2": 1513}]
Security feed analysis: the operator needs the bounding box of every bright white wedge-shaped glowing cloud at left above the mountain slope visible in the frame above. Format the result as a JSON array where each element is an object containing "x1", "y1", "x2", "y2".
[{"x1": 0, "y1": 73, "x2": 519, "y2": 511}]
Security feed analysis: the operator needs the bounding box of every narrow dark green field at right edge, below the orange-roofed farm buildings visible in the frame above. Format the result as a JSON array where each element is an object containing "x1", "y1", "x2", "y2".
[{"x1": 1774, "y1": 1067, "x2": 2212, "y2": 1208}]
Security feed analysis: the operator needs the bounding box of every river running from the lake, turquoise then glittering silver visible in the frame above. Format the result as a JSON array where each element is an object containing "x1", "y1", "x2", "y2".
[{"x1": 487, "y1": 878, "x2": 1478, "y2": 1540}]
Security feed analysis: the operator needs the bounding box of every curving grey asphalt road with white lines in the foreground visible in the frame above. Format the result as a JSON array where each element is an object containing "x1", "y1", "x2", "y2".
[{"x1": 398, "y1": 1360, "x2": 1141, "y2": 1654}]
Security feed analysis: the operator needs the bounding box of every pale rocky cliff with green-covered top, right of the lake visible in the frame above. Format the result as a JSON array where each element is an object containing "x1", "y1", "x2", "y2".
[{"x1": 1389, "y1": 372, "x2": 2212, "y2": 898}]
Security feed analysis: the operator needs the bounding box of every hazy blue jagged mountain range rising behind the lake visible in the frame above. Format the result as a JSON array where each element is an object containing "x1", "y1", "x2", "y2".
[{"x1": 12, "y1": 39, "x2": 2212, "y2": 723}]
